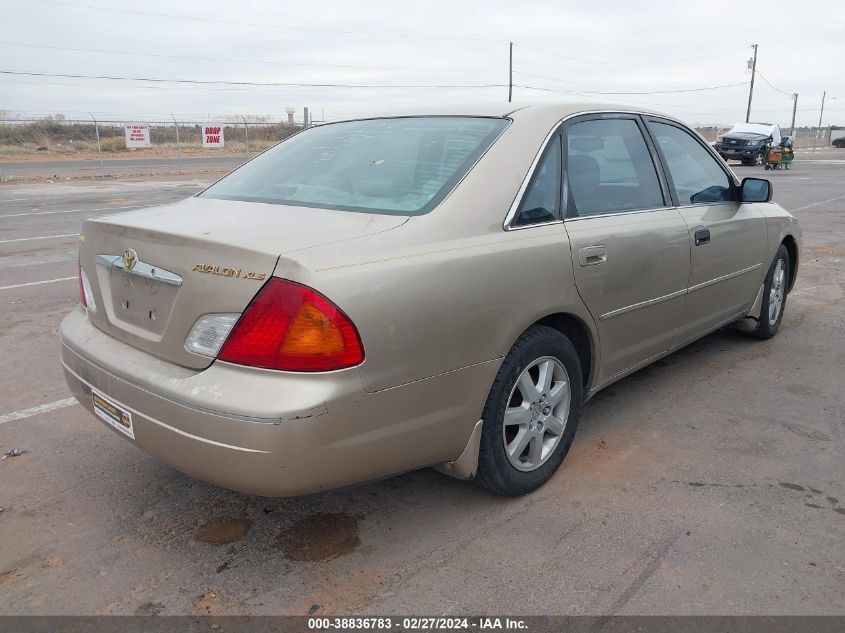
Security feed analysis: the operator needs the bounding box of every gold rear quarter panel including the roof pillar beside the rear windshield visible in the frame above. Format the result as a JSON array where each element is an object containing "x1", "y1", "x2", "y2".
[{"x1": 274, "y1": 111, "x2": 592, "y2": 392}]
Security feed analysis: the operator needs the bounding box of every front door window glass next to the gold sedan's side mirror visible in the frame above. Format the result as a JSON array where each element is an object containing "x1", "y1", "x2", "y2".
[{"x1": 648, "y1": 121, "x2": 736, "y2": 206}]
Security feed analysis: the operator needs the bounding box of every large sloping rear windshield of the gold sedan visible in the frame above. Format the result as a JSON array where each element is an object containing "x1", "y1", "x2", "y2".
[{"x1": 200, "y1": 117, "x2": 509, "y2": 215}]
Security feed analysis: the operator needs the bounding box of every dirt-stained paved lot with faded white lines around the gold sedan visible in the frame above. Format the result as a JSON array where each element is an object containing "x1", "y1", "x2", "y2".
[{"x1": 0, "y1": 160, "x2": 845, "y2": 615}]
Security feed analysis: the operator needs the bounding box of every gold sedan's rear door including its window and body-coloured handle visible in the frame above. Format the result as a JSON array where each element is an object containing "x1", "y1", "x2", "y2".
[{"x1": 562, "y1": 114, "x2": 689, "y2": 384}]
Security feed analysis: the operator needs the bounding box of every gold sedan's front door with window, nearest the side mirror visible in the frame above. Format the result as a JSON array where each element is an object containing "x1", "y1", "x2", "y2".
[{"x1": 647, "y1": 117, "x2": 766, "y2": 346}]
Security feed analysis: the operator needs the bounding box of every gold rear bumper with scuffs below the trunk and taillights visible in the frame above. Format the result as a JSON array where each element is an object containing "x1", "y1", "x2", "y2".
[{"x1": 61, "y1": 308, "x2": 499, "y2": 496}]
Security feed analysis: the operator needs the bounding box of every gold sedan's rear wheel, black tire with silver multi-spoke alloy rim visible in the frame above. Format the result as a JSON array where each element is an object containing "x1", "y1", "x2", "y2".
[{"x1": 475, "y1": 325, "x2": 584, "y2": 497}]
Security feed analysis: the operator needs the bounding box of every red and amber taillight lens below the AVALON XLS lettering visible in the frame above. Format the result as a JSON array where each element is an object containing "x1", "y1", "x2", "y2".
[{"x1": 217, "y1": 278, "x2": 364, "y2": 371}]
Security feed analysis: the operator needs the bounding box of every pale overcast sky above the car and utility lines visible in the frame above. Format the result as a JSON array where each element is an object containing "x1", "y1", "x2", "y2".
[{"x1": 0, "y1": 0, "x2": 845, "y2": 125}]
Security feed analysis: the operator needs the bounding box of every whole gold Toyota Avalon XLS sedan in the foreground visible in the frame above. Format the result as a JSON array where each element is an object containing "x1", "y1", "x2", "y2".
[{"x1": 61, "y1": 103, "x2": 801, "y2": 496}]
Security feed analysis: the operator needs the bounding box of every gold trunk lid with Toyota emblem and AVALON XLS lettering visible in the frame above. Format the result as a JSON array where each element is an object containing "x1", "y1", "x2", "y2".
[{"x1": 80, "y1": 198, "x2": 407, "y2": 369}]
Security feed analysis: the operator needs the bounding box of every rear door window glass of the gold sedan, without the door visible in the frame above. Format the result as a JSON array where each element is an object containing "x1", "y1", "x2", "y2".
[{"x1": 566, "y1": 119, "x2": 665, "y2": 216}]
